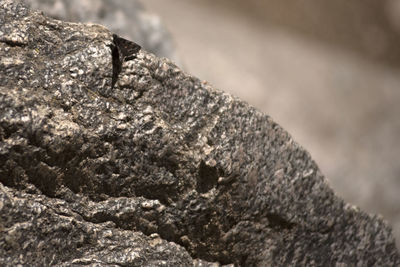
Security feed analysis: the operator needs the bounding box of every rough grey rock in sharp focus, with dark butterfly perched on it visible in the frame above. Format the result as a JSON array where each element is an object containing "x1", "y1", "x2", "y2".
[{"x1": 0, "y1": 0, "x2": 400, "y2": 266}]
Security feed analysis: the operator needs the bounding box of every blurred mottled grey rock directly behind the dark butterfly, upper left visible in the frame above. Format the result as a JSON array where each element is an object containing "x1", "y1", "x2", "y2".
[{"x1": 25, "y1": 0, "x2": 181, "y2": 64}]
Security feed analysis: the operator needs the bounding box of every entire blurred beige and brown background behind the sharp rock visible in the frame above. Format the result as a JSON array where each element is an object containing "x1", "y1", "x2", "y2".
[{"x1": 28, "y1": 0, "x2": 400, "y2": 248}]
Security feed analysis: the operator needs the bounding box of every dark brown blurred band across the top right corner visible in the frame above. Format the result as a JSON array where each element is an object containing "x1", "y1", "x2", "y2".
[{"x1": 206, "y1": 0, "x2": 400, "y2": 66}]
